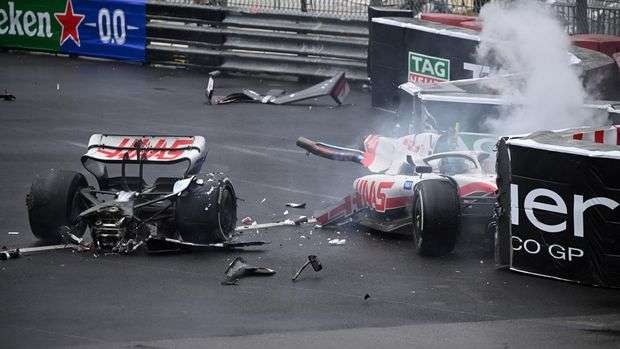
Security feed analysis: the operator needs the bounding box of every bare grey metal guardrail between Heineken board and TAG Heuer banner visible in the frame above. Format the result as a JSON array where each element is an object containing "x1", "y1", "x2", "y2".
[{"x1": 146, "y1": 1, "x2": 368, "y2": 81}]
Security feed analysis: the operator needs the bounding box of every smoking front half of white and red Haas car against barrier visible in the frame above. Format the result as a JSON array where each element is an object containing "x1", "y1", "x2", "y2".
[{"x1": 297, "y1": 131, "x2": 497, "y2": 256}]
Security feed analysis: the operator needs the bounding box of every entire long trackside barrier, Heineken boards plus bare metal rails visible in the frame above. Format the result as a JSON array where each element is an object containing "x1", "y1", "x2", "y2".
[{"x1": 0, "y1": 0, "x2": 368, "y2": 81}]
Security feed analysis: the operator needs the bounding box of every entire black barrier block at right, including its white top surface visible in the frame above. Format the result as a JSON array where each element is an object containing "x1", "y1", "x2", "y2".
[{"x1": 496, "y1": 125, "x2": 620, "y2": 287}]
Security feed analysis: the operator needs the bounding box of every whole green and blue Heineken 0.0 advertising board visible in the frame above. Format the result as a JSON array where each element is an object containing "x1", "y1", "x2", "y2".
[{"x1": 0, "y1": 0, "x2": 146, "y2": 61}]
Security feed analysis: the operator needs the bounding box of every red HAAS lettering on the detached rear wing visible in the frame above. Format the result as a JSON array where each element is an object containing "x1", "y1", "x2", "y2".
[{"x1": 97, "y1": 138, "x2": 194, "y2": 161}]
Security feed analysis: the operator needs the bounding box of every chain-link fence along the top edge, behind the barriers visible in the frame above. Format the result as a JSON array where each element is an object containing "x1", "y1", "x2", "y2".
[{"x1": 159, "y1": 0, "x2": 620, "y2": 35}]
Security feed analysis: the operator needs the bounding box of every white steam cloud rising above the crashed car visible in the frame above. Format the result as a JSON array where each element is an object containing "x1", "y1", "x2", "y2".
[{"x1": 477, "y1": 0, "x2": 594, "y2": 134}]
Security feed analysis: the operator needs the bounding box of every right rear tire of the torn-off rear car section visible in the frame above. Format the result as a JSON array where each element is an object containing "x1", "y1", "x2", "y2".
[{"x1": 175, "y1": 175, "x2": 237, "y2": 244}]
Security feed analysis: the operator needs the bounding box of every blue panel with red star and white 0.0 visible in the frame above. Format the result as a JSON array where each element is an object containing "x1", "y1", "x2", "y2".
[{"x1": 54, "y1": 0, "x2": 146, "y2": 62}]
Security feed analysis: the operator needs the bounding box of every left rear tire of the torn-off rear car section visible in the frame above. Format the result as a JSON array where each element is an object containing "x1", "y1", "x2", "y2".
[{"x1": 26, "y1": 169, "x2": 88, "y2": 243}]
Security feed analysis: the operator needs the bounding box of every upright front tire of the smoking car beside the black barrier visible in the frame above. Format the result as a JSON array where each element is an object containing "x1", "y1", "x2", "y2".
[{"x1": 412, "y1": 178, "x2": 460, "y2": 257}]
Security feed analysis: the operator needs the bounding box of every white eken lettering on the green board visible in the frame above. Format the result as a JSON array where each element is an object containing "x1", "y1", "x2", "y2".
[{"x1": 0, "y1": 2, "x2": 52, "y2": 38}]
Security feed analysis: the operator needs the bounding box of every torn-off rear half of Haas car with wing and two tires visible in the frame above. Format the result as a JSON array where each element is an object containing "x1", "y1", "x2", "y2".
[{"x1": 26, "y1": 134, "x2": 260, "y2": 253}]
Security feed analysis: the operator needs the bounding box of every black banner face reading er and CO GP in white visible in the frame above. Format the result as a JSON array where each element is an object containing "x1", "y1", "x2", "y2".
[{"x1": 502, "y1": 141, "x2": 620, "y2": 287}]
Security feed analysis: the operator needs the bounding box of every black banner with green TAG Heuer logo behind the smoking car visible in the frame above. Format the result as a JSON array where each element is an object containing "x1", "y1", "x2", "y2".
[{"x1": 368, "y1": 17, "x2": 488, "y2": 110}]
